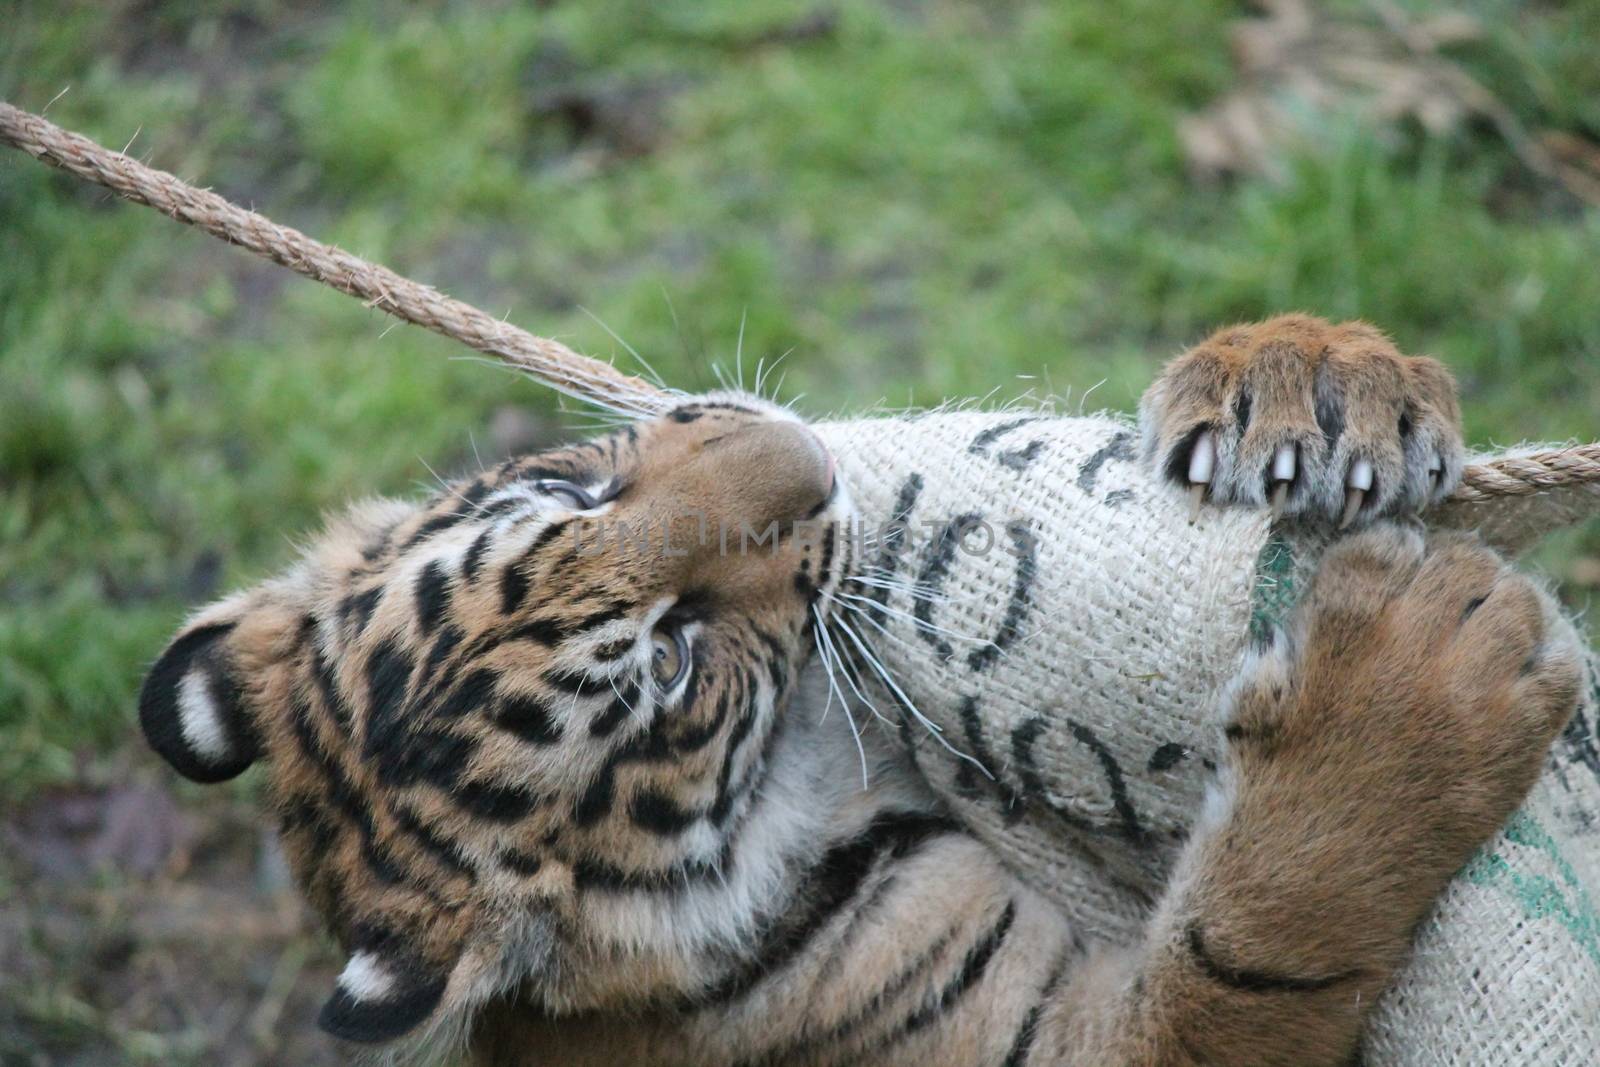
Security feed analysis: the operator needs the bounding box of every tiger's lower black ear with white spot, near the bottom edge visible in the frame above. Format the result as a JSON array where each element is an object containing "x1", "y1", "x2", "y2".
[{"x1": 317, "y1": 949, "x2": 450, "y2": 1045}]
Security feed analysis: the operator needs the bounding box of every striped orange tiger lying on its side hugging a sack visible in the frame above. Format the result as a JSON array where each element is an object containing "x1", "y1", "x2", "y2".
[{"x1": 139, "y1": 315, "x2": 1579, "y2": 1067}]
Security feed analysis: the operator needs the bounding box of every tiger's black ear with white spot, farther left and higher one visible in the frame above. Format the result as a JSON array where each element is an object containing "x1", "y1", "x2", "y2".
[{"x1": 139, "y1": 622, "x2": 259, "y2": 782}]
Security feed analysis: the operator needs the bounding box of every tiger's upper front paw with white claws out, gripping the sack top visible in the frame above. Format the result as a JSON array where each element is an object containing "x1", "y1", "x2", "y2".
[{"x1": 1139, "y1": 315, "x2": 1466, "y2": 526}]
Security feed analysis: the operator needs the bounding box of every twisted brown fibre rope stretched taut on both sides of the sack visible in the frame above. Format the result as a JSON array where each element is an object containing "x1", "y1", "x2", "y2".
[{"x1": 0, "y1": 101, "x2": 1600, "y2": 504}]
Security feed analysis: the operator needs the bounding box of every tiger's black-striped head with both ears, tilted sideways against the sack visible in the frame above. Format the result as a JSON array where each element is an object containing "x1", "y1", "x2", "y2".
[{"x1": 139, "y1": 394, "x2": 850, "y2": 1041}]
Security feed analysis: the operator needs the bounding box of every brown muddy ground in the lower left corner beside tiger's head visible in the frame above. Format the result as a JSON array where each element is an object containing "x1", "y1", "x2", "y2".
[{"x1": 0, "y1": 739, "x2": 344, "y2": 1067}]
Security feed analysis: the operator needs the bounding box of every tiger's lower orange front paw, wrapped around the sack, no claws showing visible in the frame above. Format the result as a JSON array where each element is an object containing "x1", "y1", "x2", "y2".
[{"x1": 1227, "y1": 523, "x2": 1582, "y2": 921}]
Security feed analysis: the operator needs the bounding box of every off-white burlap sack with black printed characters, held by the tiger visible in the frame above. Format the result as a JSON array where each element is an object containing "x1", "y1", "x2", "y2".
[{"x1": 822, "y1": 413, "x2": 1600, "y2": 1067}]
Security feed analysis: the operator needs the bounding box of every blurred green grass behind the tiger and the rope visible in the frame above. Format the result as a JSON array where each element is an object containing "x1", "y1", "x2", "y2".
[{"x1": 0, "y1": 0, "x2": 1600, "y2": 800}]
